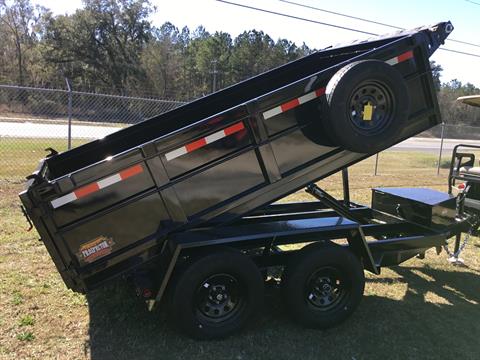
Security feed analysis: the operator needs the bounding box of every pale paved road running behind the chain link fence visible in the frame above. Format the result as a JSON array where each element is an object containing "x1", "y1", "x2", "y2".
[{"x1": 0, "y1": 119, "x2": 480, "y2": 152}]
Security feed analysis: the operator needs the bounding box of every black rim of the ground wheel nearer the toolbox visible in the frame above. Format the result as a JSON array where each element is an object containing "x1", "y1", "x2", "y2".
[{"x1": 305, "y1": 266, "x2": 349, "y2": 311}]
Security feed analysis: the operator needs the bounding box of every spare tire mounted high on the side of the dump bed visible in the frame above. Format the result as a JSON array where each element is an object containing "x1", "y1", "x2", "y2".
[{"x1": 323, "y1": 60, "x2": 410, "y2": 154}]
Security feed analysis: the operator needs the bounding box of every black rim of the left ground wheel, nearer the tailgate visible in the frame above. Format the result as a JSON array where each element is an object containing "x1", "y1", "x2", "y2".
[{"x1": 195, "y1": 274, "x2": 245, "y2": 323}]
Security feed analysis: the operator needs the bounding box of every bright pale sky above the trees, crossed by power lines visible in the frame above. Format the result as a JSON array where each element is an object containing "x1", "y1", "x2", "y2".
[{"x1": 33, "y1": 0, "x2": 480, "y2": 88}]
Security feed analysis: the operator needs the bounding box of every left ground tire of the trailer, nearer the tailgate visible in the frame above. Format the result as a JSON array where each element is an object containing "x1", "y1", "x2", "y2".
[{"x1": 169, "y1": 248, "x2": 264, "y2": 340}]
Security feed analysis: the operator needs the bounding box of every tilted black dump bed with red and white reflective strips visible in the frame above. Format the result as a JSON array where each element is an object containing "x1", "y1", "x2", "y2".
[{"x1": 20, "y1": 22, "x2": 453, "y2": 292}]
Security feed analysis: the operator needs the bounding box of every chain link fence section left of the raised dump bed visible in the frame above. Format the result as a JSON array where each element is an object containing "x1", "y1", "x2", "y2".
[{"x1": 0, "y1": 85, "x2": 183, "y2": 178}]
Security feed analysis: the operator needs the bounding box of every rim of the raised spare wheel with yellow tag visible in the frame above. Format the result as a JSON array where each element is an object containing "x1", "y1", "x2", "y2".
[{"x1": 348, "y1": 81, "x2": 396, "y2": 136}]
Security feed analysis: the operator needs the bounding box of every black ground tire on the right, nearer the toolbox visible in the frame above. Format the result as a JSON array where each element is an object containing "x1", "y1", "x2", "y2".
[{"x1": 282, "y1": 243, "x2": 365, "y2": 329}]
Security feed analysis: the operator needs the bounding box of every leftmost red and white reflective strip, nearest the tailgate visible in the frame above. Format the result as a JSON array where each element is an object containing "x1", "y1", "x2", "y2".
[{"x1": 50, "y1": 164, "x2": 143, "y2": 209}]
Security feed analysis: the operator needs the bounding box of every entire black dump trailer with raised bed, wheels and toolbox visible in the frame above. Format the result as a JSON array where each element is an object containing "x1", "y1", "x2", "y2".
[{"x1": 20, "y1": 22, "x2": 473, "y2": 338}]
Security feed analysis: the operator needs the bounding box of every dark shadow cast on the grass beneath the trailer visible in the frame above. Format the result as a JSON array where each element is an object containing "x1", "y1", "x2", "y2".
[{"x1": 86, "y1": 267, "x2": 480, "y2": 360}]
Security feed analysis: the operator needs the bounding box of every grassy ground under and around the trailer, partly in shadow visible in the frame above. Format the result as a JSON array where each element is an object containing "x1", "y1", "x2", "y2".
[{"x1": 0, "y1": 139, "x2": 480, "y2": 360}]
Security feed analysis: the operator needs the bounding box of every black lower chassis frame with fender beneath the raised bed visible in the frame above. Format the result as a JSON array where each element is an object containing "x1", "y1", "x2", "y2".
[{"x1": 143, "y1": 169, "x2": 477, "y2": 311}]
